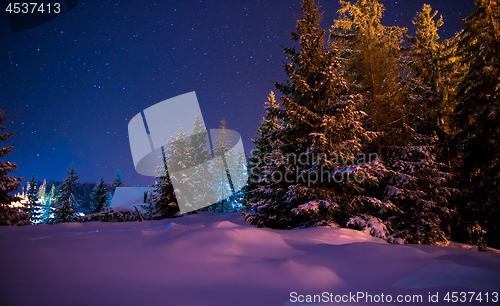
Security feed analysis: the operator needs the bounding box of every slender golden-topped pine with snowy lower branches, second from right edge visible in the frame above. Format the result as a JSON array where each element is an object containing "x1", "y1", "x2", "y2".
[{"x1": 366, "y1": 5, "x2": 458, "y2": 244}]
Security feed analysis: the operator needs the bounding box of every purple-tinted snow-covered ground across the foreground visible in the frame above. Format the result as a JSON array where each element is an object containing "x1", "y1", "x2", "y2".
[{"x1": 0, "y1": 213, "x2": 500, "y2": 306}]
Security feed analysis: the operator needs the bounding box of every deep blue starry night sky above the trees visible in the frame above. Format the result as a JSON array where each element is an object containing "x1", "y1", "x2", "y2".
[{"x1": 0, "y1": 0, "x2": 475, "y2": 186}]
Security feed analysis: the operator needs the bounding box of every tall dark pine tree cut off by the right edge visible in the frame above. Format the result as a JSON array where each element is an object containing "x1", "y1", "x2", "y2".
[{"x1": 454, "y1": 0, "x2": 500, "y2": 247}]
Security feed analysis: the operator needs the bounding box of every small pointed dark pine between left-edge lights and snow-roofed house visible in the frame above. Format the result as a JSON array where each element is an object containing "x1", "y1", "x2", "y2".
[{"x1": 54, "y1": 166, "x2": 79, "y2": 222}]
